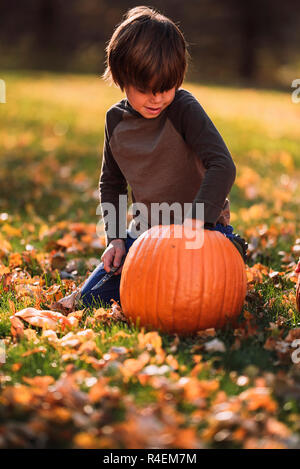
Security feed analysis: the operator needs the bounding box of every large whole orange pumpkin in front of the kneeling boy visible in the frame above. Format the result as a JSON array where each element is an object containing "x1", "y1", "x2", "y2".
[{"x1": 120, "y1": 225, "x2": 247, "y2": 334}]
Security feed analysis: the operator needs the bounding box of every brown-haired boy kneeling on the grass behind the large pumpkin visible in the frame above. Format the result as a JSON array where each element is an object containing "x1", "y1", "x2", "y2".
[{"x1": 81, "y1": 6, "x2": 247, "y2": 306}]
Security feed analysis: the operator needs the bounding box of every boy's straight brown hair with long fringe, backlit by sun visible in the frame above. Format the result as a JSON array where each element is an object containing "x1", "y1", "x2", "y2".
[{"x1": 102, "y1": 6, "x2": 189, "y2": 94}]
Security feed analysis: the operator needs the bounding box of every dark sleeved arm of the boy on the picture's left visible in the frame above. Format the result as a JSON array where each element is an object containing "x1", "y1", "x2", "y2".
[{"x1": 99, "y1": 122, "x2": 127, "y2": 245}]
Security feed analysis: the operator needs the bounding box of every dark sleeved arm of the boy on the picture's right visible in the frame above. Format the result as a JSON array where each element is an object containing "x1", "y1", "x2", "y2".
[{"x1": 183, "y1": 95, "x2": 236, "y2": 226}]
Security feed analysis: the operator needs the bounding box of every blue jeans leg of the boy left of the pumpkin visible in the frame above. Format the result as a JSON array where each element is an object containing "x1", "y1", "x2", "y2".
[{"x1": 80, "y1": 230, "x2": 135, "y2": 308}]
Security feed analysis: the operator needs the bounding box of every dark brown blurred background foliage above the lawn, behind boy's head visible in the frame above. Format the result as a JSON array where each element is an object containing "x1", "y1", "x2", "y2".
[{"x1": 0, "y1": 0, "x2": 300, "y2": 87}]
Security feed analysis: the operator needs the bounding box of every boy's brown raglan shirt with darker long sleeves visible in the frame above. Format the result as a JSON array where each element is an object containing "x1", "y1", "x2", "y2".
[{"x1": 99, "y1": 88, "x2": 236, "y2": 249}]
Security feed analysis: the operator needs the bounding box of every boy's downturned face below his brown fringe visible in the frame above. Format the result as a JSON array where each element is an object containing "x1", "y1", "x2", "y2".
[{"x1": 124, "y1": 85, "x2": 176, "y2": 119}]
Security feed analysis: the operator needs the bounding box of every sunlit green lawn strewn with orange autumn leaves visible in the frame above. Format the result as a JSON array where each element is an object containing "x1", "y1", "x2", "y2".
[{"x1": 0, "y1": 71, "x2": 300, "y2": 448}]
